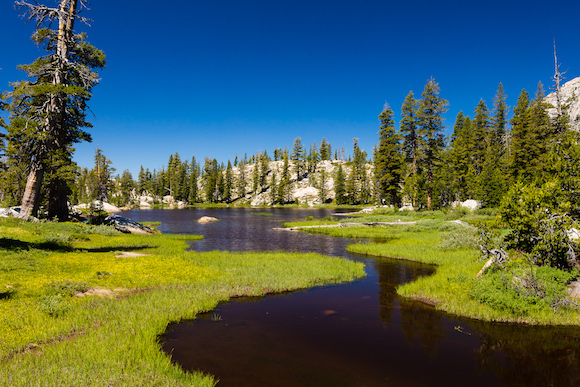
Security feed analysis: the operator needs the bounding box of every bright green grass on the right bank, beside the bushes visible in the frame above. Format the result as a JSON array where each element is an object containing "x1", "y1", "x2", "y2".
[{"x1": 290, "y1": 214, "x2": 580, "y2": 325}]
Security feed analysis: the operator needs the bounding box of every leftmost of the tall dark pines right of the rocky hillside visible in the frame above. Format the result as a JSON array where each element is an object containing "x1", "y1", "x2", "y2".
[{"x1": 375, "y1": 105, "x2": 403, "y2": 206}]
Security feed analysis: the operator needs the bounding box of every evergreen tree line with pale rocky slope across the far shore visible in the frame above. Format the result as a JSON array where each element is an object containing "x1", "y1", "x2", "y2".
[{"x1": 62, "y1": 73, "x2": 580, "y2": 214}]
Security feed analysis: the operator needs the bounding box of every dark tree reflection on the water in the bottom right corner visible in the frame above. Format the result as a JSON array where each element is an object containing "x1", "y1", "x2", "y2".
[{"x1": 469, "y1": 321, "x2": 580, "y2": 386}]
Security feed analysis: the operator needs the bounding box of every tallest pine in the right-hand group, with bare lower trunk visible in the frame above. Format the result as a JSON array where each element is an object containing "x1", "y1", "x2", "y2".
[{"x1": 417, "y1": 78, "x2": 448, "y2": 209}]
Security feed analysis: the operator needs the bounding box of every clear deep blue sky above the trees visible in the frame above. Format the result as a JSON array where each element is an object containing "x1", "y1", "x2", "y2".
[{"x1": 0, "y1": 0, "x2": 580, "y2": 178}]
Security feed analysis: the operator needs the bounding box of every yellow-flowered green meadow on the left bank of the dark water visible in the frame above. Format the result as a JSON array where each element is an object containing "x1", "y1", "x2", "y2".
[{"x1": 0, "y1": 219, "x2": 364, "y2": 386}]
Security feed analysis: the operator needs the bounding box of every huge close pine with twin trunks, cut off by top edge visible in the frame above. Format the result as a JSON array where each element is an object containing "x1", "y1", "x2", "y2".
[{"x1": 6, "y1": 0, "x2": 105, "y2": 220}]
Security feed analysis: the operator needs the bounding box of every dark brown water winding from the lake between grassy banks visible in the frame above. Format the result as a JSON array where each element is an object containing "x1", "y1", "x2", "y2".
[{"x1": 126, "y1": 209, "x2": 580, "y2": 386}]
